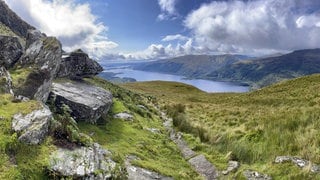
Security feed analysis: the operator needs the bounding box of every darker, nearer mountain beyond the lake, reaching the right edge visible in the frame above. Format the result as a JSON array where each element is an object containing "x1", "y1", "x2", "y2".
[{"x1": 207, "y1": 49, "x2": 320, "y2": 87}]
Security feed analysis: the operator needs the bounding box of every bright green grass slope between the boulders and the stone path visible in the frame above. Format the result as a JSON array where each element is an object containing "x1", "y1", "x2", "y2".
[{"x1": 79, "y1": 78, "x2": 201, "y2": 179}]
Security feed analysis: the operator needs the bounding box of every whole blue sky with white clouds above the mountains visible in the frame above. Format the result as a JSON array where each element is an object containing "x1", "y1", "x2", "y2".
[{"x1": 5, "y1": 0, "x2": 320, "y2": 60}]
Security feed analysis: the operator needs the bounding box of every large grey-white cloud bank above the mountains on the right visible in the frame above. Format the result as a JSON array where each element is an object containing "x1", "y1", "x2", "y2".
[{"x1": 185, "y1": 0, "x2": 320, "y2": 53}]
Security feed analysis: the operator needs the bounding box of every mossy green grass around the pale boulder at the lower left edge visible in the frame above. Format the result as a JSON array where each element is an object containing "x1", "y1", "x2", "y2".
[{"x1": 0, "y1": 94, "x2": 54, "y2": 179}]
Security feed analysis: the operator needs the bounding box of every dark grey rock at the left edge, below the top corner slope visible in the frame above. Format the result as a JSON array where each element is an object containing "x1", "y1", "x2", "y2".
[{"x1": 0, "y1": 36, "x2": 23, "y2": 68}]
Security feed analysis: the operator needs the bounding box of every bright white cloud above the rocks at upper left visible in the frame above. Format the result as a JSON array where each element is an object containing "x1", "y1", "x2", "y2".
[{"x1": 5, "y1": 0, "x2": 118, "y2": 57}]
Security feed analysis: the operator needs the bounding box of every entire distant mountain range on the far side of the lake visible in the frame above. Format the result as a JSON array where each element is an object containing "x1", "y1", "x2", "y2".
[{"x1": 135, "y1": 49, "x2": 320, "y2": 88}]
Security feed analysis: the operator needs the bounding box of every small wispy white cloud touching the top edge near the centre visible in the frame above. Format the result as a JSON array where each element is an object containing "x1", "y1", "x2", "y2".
[{"x1": 158, "y1": 0, "x2": 178, "y2": 20}]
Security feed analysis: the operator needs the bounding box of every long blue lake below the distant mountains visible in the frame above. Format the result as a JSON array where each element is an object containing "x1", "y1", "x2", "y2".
[{"x1": 103, "y1": 64, "x2": 249, "y2": 92}]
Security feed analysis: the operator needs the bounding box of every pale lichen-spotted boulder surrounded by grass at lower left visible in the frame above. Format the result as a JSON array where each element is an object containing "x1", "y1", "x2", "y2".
[{"x1": 12, "y1": 105, "x2": 52, "y2": 144}]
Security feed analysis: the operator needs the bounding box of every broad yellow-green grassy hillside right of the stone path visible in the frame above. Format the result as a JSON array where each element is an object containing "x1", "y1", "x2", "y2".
[{"x1": 124, "y1": 75, "x2": 320, "y2": 179}]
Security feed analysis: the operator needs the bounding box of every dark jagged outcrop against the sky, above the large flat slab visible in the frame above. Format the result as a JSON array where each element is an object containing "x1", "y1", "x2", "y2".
[{"x1": 57, "y1": 49, "x2": 103, "y2": 79}]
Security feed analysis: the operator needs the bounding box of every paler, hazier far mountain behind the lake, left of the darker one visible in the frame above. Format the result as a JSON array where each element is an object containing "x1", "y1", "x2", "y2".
[{"x1": 134, "y1": 54, "x2": 249, "y2": 78}]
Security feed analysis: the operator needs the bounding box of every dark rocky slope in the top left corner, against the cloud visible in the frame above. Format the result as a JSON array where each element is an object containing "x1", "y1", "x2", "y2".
[{"x1": 0, "y1": 1, "x2": 35, "y2": 37}]
